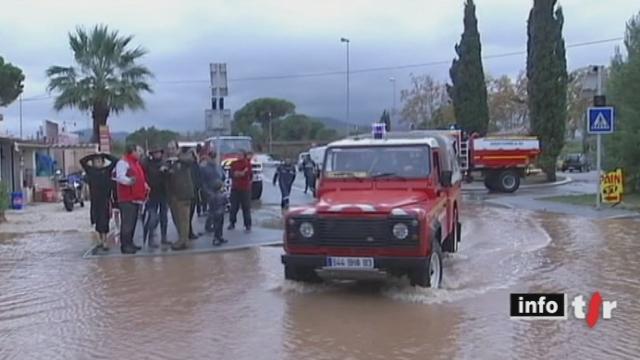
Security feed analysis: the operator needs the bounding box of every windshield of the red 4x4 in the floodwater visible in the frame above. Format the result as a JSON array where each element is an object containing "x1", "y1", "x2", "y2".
[{"x1": 324, "y1": 145, "x2": 431, "y2": 178}]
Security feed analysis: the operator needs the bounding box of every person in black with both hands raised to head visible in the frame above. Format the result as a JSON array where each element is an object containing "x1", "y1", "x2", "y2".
[{"x1": 80, "y1": 153, "x2": 118, "y2": 250}]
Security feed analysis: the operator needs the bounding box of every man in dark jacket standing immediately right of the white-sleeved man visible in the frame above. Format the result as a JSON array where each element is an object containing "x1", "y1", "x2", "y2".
[{"x1": 142, "y1": 146, "x2": 169, "y2": 247}]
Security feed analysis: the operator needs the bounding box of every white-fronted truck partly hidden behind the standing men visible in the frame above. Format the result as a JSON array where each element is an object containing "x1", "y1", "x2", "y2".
[{"x1": 204, "y1": 136, "x2": 263, "y2": 200}]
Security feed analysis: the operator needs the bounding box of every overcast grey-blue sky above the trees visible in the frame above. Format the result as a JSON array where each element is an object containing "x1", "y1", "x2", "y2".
[{"x1": 0, "y1": 0, "x2": 640, "y2": 134}]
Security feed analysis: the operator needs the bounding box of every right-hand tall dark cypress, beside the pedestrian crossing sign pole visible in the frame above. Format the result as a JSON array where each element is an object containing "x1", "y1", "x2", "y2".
[{"x1": 527, "y1": 0, "x2": 568, "y2": 181}]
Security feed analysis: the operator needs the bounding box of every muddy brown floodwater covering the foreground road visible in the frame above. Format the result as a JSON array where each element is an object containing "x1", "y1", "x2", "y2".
[{"x1": 0, "y1": 206, "x2": 640, "y2": 359}]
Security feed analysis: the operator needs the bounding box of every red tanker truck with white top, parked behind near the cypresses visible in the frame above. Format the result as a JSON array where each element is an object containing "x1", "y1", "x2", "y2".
[{"x1": 454, "y1": 134, "x2": 540, "y2": 193}]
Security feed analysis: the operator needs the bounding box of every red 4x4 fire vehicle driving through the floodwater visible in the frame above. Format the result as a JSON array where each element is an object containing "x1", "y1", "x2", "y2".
[{"x1": 282, "y1": 132, "x2": 462, "y2": 288}]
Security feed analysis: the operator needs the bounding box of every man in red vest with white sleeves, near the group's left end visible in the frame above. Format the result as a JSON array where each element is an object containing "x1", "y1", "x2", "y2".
[{"x1": 115, "y1": 145, "x2": 149, "y2": 254}]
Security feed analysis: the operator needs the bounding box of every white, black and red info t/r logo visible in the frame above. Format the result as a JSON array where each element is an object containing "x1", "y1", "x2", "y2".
[{"x1": 510, "y1": 291, "x2": 618, "y2": 328}]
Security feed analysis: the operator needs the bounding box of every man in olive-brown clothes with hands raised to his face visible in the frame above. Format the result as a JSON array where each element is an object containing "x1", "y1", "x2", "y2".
[{"x1": 161, "y1": 141, "x2": 194, "y2": 250}]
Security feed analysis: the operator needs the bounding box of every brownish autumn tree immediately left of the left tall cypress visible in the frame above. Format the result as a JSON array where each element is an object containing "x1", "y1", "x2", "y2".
[{"x1": 400, "y1": 75, "x2": 455, "y2": 129}]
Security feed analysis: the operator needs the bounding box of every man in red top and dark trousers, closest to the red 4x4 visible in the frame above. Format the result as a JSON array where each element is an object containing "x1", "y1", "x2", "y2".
[{"x1": 228, "y1": 151, "x2": 253, "y2": 232}]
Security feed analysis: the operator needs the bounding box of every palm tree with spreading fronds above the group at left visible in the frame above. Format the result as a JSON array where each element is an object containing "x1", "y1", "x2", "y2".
[{"x1": 47, "y1": 25, "x2": 153, "y2": 142}]
